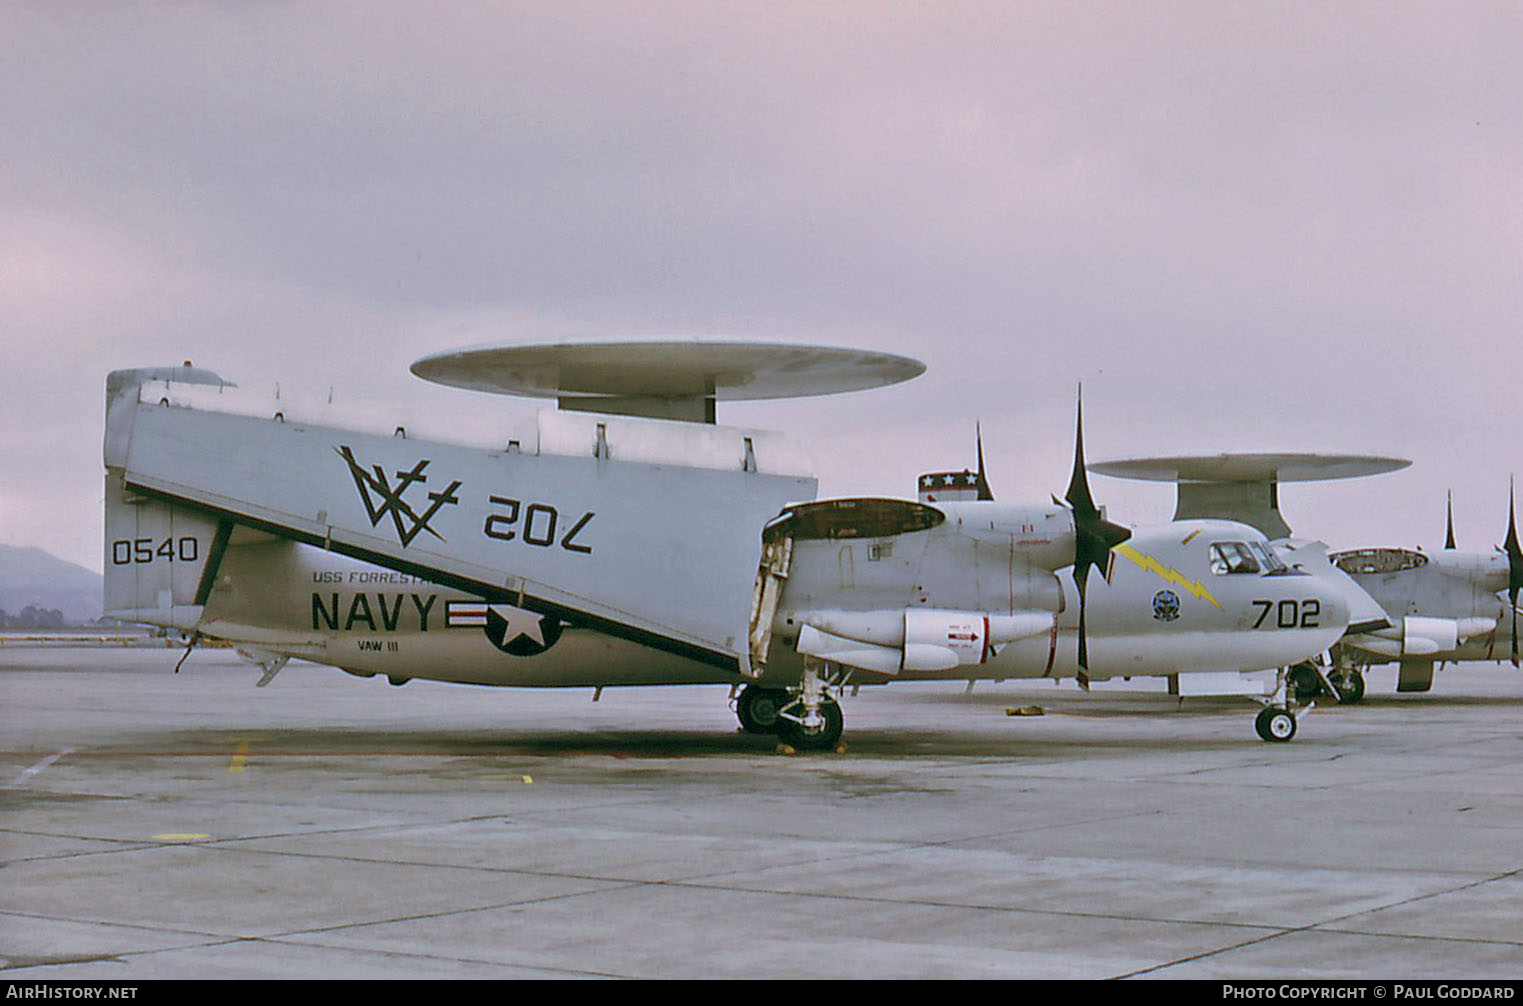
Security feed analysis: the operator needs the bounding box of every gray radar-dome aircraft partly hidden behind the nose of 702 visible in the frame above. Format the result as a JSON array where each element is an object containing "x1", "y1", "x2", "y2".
[{"x1": 1090, "y1": 454, "x2": 1523, "y2": 703}]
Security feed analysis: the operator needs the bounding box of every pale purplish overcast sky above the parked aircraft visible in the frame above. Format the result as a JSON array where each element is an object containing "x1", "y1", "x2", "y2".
[{"x1": 0, "y1": 0, "x2": 1523, "y2": 569}]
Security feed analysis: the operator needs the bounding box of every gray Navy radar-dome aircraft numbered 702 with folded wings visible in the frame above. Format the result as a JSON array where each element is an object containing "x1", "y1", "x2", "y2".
[{"x1": 104, "y1": 342, "x2": 1348, "y2": 747}]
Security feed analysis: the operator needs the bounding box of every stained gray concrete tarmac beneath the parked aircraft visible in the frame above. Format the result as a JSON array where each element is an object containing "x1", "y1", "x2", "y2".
[{"x1": 0, "y1": 648, "x2": 1523, "y2": 982}]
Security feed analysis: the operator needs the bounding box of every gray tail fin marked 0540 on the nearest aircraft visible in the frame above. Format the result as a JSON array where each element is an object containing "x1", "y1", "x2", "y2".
[{"x1": 104, "y1": 362, "x2": 231, "y2": 630}]
